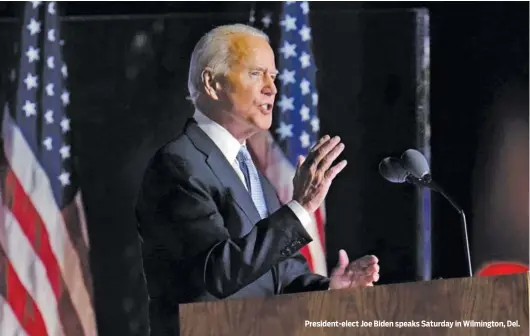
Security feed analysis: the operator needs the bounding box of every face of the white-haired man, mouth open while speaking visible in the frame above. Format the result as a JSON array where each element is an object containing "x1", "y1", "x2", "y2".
[{"x1": 209, "y1": 34, "x2": 277, "y2": 134}]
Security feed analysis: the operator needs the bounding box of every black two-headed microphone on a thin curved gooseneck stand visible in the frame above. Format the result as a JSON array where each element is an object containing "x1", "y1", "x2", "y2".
[{"x1": 379, "y1": 149, "x2": 473, "y2": 277}]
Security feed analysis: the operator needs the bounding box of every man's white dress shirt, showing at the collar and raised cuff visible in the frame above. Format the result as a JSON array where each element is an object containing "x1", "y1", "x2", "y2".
[{"x1": 193, "y1": 110, "x2": 311, "y2": 228}]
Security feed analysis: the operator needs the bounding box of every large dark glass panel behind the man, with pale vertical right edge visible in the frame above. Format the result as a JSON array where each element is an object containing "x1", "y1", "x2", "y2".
[{"x1": 0, "y1": 10, "x2": 429, "y2": 335}]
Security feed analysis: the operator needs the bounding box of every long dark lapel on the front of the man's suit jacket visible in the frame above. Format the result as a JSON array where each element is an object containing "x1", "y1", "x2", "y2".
[{"x1": 185, "y1": 119, "x2": 261, "y2": 224}]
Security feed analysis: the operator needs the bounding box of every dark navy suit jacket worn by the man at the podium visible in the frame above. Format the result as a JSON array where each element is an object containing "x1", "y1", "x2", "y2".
[{"x1": 136, "y1": 119, "x2": 329, "y2": 336}]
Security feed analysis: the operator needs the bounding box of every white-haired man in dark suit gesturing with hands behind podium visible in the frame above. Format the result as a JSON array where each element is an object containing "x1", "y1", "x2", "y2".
[{"x1": 136, "y1": 25, "x2": 379, "y2": 335}]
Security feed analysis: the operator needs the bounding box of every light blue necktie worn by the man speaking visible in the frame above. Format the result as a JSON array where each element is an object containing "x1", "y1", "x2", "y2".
[{"x1": 236, "y1": 146, "x2": 268, "y2": 218}]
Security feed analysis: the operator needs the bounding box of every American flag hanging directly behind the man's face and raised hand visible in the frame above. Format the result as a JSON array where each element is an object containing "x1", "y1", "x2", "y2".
[{"x1": 249, "y1": 1, "x2": 327, "y2": 276}]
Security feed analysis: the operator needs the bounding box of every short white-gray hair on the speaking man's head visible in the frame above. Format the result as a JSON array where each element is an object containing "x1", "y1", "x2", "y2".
[{"x1": 188, "y1": 23, "x2": 269, "y2": 105}]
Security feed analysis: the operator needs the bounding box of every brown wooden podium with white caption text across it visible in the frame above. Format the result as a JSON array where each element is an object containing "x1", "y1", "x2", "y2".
[{"x1": 179, "y1": 273, "x2": 529, "y2": 336}]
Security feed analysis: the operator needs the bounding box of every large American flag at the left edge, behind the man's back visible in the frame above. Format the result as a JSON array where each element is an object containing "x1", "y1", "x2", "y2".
[{"x1": 0, "y1": 1, "x2": 97, "y2": 336}]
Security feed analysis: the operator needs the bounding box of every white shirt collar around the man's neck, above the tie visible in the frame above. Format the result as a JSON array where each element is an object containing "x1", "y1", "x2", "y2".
[{"x1": 193, "y1": 109, "x2": 242, "y2": 163}]
